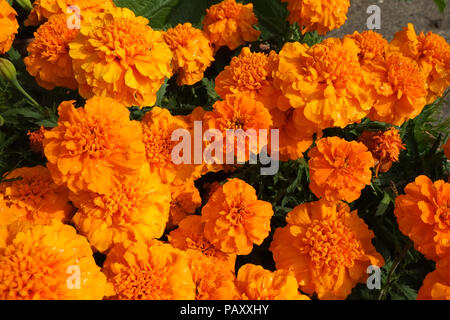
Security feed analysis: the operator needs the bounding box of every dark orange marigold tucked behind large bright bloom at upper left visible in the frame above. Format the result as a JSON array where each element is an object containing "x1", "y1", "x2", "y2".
[{"x1": 24, "y1": 14, "x2": 78, "y2": 90}]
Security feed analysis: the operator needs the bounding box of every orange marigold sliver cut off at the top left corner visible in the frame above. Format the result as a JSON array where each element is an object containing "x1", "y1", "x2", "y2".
[{"x1": 0, "y1": 0, "x2": 19, "y2": 54}]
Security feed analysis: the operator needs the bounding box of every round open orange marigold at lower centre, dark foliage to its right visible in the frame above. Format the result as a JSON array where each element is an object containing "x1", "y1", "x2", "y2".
[{"x1": 202, "y1": 179, "x2": 273, "y2": 255}]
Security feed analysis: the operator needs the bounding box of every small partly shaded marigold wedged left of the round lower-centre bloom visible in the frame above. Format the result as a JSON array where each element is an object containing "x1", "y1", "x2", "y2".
[{"x1": 168, "y1": 179, "x2": 202, "y2": 227}]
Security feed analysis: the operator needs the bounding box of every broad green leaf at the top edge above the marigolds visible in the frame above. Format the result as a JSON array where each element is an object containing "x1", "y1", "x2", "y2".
[{"x1": 114, "y1": 0, "x2": 180, "y2": 29}]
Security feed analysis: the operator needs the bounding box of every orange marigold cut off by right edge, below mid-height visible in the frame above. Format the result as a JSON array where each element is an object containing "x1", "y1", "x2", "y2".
[{"x1": 394, "y1": 175, "x2": 450, "y2": 261}]
